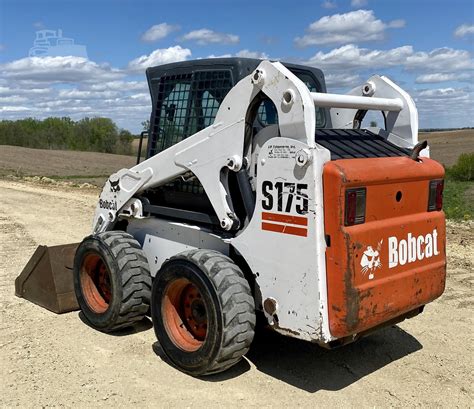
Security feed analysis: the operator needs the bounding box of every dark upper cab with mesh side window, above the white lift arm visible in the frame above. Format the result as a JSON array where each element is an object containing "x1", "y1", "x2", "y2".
[{"x1": 146, "y1": 58, "x2": 330, "y2": 159}]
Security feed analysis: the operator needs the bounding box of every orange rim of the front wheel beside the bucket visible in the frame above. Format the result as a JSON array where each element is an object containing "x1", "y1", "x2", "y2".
[{"x1": 80, "y1": 253, "x2": 111, "y2": 314}]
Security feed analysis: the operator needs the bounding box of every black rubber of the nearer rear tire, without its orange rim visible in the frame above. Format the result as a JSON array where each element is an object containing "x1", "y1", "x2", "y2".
[{"x1": 151, "y1": 250, "x2": 255, "y2": 376}]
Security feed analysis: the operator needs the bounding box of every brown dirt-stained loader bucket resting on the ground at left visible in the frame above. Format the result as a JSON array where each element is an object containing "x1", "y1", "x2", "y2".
[{"x1": 15, "y1": 243, "x2": 79, "y2": 314}]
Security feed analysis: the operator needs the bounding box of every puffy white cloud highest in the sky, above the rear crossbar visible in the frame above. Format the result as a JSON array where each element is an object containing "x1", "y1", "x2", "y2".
[{"x1": 295, "y1": 10, "x2": 405, "y2": 47}]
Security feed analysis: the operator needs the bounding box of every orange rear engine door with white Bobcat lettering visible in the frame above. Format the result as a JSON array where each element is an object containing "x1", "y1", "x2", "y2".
[{"x1": 323, "y1": 157, "x2": 446, "y2": 338}]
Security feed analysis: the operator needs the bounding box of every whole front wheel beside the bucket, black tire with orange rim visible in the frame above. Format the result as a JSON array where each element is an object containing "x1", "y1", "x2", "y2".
[{"x1": 74, "y1": 231, "x2": 151, "y2": 332}]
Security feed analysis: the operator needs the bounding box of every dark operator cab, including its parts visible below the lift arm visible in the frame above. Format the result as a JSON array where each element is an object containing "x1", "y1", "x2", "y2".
[{"x1": 146, "y1": 58, "x2": 331, "y2": 222}]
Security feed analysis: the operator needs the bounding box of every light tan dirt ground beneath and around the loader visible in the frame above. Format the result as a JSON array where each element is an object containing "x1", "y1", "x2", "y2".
[{"x1": 0, "y1": 180, "x2": 474, "y2": 408}]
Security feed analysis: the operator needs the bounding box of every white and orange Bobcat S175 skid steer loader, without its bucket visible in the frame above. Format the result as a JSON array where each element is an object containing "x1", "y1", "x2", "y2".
[{"x1": 13, "y1": 58, "x2": 446, "y2": 375}]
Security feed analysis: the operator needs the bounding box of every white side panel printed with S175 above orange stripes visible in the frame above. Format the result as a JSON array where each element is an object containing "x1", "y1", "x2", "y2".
[{"x1": 231, "y1": 138, "x2": 329, "y2": 342}]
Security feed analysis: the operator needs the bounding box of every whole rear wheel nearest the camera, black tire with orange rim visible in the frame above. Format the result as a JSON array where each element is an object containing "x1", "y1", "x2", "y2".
[{"x1": 151, "y1": 250, "x2": 255, "y2": 376}]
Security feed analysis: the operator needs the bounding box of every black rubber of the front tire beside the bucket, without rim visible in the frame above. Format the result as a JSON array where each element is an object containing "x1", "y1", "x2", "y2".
[{"x1": 74, "y1": 231, "x2": 151, "y2": 332}]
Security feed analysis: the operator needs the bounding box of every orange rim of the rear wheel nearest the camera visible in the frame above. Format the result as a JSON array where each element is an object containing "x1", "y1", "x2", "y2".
[{"x1": 161, "y1": 278, "x2": 207, "y2": 352}]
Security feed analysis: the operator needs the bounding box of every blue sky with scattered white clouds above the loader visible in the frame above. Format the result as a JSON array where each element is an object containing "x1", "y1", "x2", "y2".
[{"x1": 0, "y1": 0, "x2": 474, "y2": 132}]
